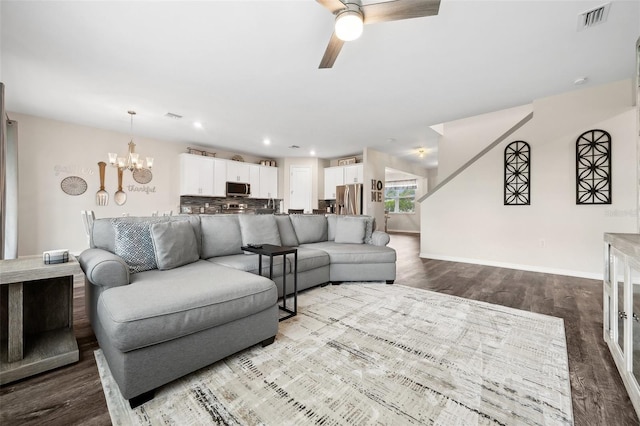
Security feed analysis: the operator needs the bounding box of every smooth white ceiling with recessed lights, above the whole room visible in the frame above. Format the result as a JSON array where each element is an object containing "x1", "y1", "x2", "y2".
[{"x1": 0, "y1": 0, "x2": 640, "y2": 167}]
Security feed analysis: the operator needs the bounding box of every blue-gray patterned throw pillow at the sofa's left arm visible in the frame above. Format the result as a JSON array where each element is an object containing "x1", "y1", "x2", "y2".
[{"x1": 111, "y1": 218, "x2": 163, "y2": 274}]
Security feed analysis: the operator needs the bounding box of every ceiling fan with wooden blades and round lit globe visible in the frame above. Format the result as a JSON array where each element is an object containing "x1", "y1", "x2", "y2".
[{"x1": 316, "y1": 0, "x2": 440, "y2": 68}]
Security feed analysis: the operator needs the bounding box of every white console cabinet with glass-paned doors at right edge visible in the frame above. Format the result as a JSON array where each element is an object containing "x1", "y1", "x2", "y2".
[{"x1": 603, "y1": 234, "x2": 640, "y2": 417}]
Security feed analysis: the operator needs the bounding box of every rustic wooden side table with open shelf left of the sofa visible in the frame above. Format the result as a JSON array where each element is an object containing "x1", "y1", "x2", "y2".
[{"x1": 0, "y1": 256, "x2": 82, "y2": 385}]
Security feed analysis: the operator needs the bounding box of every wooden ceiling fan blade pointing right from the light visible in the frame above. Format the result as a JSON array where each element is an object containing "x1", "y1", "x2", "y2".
[{"x1": 362, "y1": 0, "x2": 440, "y2": 24}]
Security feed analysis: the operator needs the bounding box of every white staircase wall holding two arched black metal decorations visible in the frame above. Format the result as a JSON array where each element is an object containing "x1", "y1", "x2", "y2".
[{"x1": 421, "y1": 80, "x2": 638, "y2": 278}]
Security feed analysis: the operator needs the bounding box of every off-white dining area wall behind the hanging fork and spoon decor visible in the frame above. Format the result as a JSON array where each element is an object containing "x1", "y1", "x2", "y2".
[{"x1": 8, "y1": 112, "x2": 280, "y2": 256}]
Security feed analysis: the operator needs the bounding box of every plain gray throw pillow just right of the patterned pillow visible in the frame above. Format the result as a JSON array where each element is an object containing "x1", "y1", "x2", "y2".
[{"x1": 151, "y1": 222, "x2": 200, "y2": 270}]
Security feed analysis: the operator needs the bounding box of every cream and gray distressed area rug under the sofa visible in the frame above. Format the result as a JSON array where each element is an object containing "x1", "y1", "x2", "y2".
[{"x1": 95, "y1": 283, "x2": 573, "y2": 426}]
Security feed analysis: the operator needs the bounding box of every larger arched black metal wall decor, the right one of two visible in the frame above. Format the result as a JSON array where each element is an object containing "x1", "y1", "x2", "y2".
[{"x1": 576, "y1": 130, "x2": 611, "y2": 204}]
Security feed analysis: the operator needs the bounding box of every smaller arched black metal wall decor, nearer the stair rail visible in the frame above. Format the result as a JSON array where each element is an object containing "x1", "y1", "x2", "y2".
[{"x1": 504, "y1": 141, "x2": 531, "y2": 206}]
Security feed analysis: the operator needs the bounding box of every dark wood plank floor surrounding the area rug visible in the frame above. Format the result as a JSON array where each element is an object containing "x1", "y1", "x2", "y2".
[{"x1": 0, "y1": 234, "x2": 639, "y2": 426}]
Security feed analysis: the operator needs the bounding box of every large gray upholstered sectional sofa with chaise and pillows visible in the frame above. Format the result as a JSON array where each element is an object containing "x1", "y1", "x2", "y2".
[{"x1": 78, "y1": 215, "x2": 396, "y2": 407}]
